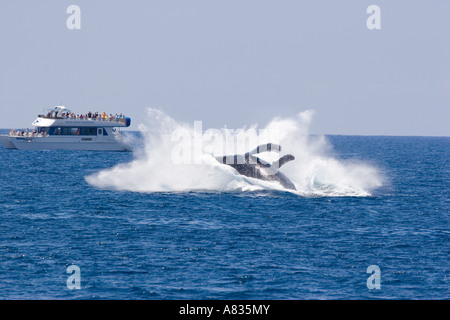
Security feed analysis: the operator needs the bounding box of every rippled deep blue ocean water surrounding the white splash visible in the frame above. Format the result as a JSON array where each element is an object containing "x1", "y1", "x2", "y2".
[{"x1": 0, "y1": 136, "x2": 450, "y2": 299}]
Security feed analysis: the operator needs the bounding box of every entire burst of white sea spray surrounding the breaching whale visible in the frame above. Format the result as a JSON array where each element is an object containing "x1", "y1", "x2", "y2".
[{"x1": 86, "y1": 109, "x2": 382, "y2": 196}]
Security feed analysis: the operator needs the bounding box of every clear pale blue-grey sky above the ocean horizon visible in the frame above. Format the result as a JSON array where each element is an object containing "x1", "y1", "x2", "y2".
[{"x1": 0, "y1": 0, "x2": 450, "y2": 136}]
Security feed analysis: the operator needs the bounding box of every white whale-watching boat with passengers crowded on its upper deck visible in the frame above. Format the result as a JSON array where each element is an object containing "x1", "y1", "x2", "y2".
[{"x1": 0, "y1": 106, "x2": 131, "y2": 151}]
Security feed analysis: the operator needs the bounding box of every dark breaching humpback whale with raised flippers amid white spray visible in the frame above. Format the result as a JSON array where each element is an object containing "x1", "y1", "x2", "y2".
[{"x1": 216, "y1": 143, "x2": 297, "y2": 190}]
